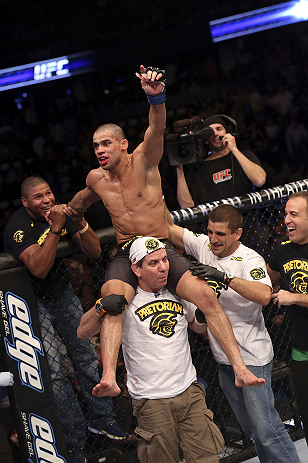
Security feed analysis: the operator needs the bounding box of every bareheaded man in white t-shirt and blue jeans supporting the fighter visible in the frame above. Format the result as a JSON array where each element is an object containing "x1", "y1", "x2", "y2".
[{"x1": 169, "y1": 204, "x2": 300, "y2": 463}]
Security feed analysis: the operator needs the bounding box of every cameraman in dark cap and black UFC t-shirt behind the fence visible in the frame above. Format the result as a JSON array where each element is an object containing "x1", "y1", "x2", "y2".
[{"x1": 176, "y1": 114, "x2": 266, "y2": 209}]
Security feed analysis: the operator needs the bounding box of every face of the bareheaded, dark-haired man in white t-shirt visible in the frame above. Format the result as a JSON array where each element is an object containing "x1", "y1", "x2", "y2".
[{"x1": 207, "y1": 220, "x2": 242, "y2": 257}]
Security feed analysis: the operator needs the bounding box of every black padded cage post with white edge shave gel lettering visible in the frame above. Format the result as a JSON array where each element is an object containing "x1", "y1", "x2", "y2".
[{"x1": 0, "y1": 267, "x2": 67, "y2": 463}]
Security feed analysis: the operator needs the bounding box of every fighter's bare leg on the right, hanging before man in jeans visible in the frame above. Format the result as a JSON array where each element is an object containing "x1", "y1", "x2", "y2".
[{"x1": 176, "y1": 271, "x2": 265, "y2": 387}]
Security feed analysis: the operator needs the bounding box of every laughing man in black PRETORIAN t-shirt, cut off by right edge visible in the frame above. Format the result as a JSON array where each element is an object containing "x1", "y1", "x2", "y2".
[{"x1": 267, "y1": 191, "x2": 308, "y2": 443}]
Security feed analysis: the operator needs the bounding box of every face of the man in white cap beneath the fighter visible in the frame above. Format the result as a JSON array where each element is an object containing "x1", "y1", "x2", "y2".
[{"x1": 132, "y1": 249, "x2": 169, "y2": 293}]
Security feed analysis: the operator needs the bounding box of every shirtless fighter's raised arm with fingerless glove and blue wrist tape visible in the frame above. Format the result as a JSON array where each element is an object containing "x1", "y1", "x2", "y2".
[{"x1": 136, "y1": 66, "x2": 166, "y2": 167}]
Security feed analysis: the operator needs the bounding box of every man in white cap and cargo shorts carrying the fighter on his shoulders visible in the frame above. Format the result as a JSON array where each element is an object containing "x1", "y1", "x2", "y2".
[{"x1": 122, "y1": 237, "x2": 224, "y2": 463}]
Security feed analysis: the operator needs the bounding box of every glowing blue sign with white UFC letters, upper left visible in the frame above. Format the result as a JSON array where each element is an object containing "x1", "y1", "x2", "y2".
[{"x1": 0, "y1": 51, "x2": 95, "y2": 92}]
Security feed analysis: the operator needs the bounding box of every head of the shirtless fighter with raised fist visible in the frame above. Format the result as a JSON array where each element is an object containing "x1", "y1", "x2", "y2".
[{"x1": 93, "y1": 130, "x2": 128, "y2": 170}]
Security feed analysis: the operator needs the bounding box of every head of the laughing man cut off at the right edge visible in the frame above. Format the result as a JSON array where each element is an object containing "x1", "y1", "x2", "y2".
[{"x1": 284, "y1": 197, "x2": 308, "y2": 244}]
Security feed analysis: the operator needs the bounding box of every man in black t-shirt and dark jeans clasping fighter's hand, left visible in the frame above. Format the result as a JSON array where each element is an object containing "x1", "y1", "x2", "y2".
[{"x1": 4, "y1": 176, "x2": 128, "y2": 463}]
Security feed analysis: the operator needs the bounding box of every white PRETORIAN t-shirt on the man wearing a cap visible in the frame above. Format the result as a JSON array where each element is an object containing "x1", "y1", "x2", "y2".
[{"x1": 122, "y1": 287, "x2": 196, "y2": 399}]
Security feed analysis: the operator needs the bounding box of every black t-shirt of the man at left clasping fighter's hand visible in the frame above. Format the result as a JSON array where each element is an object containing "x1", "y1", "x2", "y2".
[{"x1": 3, "y1": 207, "x2": 78, "y2": 299}]
